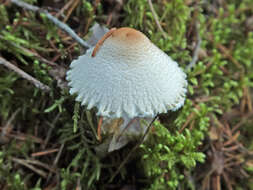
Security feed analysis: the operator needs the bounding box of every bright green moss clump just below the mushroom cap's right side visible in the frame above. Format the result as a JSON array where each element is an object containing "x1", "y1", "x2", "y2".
[{"x1": 137, "y1": 122, "x2": 205, "y2": 189}]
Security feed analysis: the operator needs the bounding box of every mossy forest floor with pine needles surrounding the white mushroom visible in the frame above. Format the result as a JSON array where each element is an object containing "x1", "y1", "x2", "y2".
[{"x1": 0, "y1": 0, "x2": 253, "y2": 190}]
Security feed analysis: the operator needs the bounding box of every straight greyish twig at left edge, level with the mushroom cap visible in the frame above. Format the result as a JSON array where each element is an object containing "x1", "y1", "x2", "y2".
[{"x1": 0, "y1": 57, "x2": 50, "y2": 92}]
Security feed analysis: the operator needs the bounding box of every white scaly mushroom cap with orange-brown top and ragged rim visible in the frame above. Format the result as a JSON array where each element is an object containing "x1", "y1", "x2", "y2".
[{"x1": 67, "y1": 28, "x2": 187, "y2": 118}]
